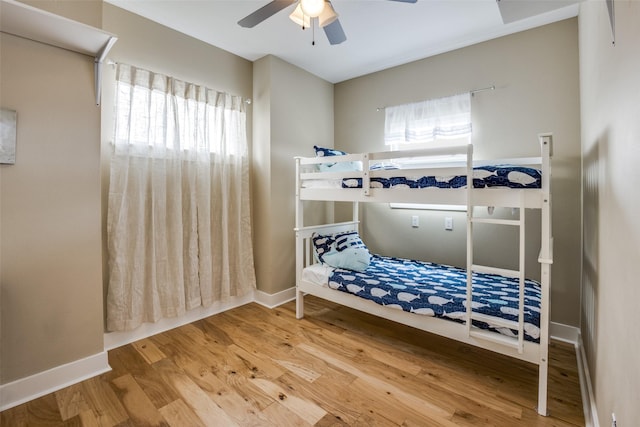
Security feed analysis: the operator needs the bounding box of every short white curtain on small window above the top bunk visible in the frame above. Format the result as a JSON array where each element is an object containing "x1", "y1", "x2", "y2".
[{"x1": 384, "y1": 93, "x2": 471, "y2": 145}]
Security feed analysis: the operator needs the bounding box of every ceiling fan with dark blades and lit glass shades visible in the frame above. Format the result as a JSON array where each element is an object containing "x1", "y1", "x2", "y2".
[{"x1": 238, "y1": 0, "x2": 418, "y2": 45}]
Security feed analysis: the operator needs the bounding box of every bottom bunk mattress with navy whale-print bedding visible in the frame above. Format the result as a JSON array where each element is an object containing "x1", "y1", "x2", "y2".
[{"x1": 302, "y1": 255, "x2": 541, "y2": 343}]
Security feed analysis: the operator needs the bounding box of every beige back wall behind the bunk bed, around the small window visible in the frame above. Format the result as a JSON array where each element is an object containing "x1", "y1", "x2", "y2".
[{"x1": 335, "y1": 19, "x2": 580, "y2": 326}]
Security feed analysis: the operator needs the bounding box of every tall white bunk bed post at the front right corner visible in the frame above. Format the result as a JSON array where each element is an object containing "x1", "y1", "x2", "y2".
[{"x1": 538, "y1": 133, "x2": 553, "y2": 416}]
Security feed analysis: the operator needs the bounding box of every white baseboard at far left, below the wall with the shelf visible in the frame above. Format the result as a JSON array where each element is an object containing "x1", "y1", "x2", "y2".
[{"x1": 0, "y1": 351, "x2": 111, "y2": 411}]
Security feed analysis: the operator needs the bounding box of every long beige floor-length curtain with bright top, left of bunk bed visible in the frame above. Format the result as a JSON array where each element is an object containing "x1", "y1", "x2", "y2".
[{"x1": 107, "y1": 64, "x2": 255, "y2": 331}]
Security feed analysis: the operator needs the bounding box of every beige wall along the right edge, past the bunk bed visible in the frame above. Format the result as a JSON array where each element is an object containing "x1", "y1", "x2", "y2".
[{"x1": 580, "y1": 0, "x2": 640, "y2": 426}]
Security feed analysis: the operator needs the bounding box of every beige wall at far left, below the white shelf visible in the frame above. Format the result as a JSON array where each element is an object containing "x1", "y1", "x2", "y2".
[{"x1": 0, "y1": 34, "x2": 103, "y2": 384}]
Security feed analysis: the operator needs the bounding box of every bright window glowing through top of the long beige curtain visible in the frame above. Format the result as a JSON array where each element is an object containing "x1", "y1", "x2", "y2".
[{"x1": 115, "y1": 64, "x2": 248, "y2": 157}]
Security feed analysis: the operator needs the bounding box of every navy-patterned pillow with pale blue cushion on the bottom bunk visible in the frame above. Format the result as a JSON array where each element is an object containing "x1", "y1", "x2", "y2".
[{"x1": 311, "y1": 231, "x2": 371, "y2": 271}]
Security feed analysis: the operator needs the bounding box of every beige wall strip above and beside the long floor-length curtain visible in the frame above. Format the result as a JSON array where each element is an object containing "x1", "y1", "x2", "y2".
[{"x1": 101, "y1": 3, "x2": 253, "y2": 318}]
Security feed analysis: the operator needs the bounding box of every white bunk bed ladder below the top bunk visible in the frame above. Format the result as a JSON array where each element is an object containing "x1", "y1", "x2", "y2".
[{"x1": 466, "y1": 190, "x2": 525, "y2": 353}]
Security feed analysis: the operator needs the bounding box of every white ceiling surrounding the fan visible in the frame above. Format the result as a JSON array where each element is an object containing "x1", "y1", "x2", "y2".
[{"x1": 106, "y1": 0, "x2": 579, "y2": 83}]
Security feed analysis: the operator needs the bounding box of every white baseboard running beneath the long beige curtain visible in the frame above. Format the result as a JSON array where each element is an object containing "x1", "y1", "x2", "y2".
[{"x1": 104, "y1": 291, "x2": 258, "y2": 350}]
